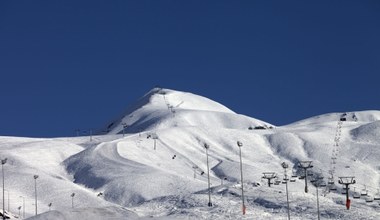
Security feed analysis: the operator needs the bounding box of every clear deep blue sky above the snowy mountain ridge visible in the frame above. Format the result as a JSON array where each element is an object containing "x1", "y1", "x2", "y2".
[{"x1": 0, "y1": 0, "x2": 380, "y2": 137}]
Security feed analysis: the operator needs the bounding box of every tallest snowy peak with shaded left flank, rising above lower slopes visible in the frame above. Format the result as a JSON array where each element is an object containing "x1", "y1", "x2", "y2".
[{"x1": 102, "y1": 87, "x2": 270, "y2": 134}]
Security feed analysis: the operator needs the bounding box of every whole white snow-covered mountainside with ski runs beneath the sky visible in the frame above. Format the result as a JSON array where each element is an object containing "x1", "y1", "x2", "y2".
[{"x1": 0, "y1": 88, "x2": 380, "y2": 220}]
